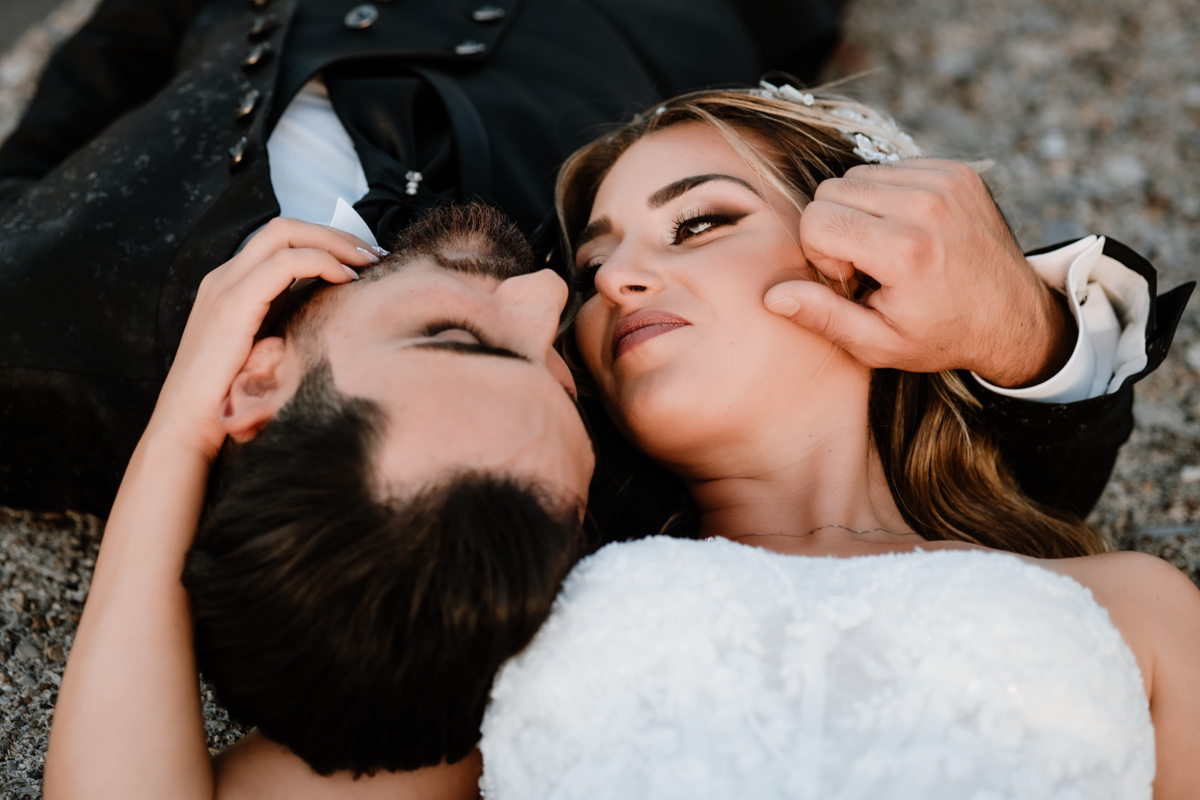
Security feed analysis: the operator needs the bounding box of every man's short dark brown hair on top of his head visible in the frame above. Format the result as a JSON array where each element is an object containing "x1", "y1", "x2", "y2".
[{"x1": 184, "y1": 362, "x2": 583, "y2": 775}]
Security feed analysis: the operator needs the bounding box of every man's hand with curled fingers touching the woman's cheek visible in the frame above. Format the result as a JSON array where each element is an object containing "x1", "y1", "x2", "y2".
[{"x1": 764, "y1": 158, "x2": 1075, "y2": 387}]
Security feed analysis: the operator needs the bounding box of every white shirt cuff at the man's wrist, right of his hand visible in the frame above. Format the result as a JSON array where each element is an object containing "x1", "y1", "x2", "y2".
[{"x1": 971, "y1": 236, "x2": 1151, "y2": 403}]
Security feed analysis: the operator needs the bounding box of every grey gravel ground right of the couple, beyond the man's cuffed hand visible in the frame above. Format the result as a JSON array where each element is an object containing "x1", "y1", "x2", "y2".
[{"x1": 830, "y1": 0, "x2": 1200, "y2": 563}]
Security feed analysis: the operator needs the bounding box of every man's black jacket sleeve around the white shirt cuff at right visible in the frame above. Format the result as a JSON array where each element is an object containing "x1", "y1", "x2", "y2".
[{"x1": 964, "y1": 239, "x2": 1195, "y2": 517}]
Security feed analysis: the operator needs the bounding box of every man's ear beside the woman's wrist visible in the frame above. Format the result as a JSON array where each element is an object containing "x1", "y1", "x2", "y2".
[{"x1": 221, "y1": 336, "x2": 301, "y2": 443}]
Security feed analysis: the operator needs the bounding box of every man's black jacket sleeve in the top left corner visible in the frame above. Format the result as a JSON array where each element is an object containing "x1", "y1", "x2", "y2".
[{"x1": 0, "y1": 0, "x2": 206, "y2": 207}]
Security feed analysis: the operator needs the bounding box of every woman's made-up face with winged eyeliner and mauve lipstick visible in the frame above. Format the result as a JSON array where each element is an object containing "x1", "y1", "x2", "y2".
[{"x1": 576, "y1": 122, "x2": 866, "y2": 462}]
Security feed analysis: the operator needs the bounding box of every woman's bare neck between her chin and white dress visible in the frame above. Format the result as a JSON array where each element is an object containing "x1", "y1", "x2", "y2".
[{"x1": 682, "y1": 376, "x2": 911, "y2": 552}]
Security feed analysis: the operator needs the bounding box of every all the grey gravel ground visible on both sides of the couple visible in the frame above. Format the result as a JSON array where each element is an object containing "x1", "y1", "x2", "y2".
[{"x1": 0, "y1": 0, "x2": 1200, "y2": 798}]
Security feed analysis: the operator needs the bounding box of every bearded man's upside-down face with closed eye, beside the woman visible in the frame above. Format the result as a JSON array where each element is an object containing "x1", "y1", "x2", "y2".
[{"x1": 286, "y1": 206, "x2": 594, "y2": 510}]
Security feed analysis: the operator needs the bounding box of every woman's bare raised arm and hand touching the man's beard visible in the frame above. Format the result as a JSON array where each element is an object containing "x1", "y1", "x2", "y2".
[{"x1": 44, "y1": 219, "x2": 378, "y2": 800}]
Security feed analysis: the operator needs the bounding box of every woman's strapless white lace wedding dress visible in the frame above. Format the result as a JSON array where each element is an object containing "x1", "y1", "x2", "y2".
[{"x1": 481, "y1": 537, "x2": 1154, "y2": 800}]
